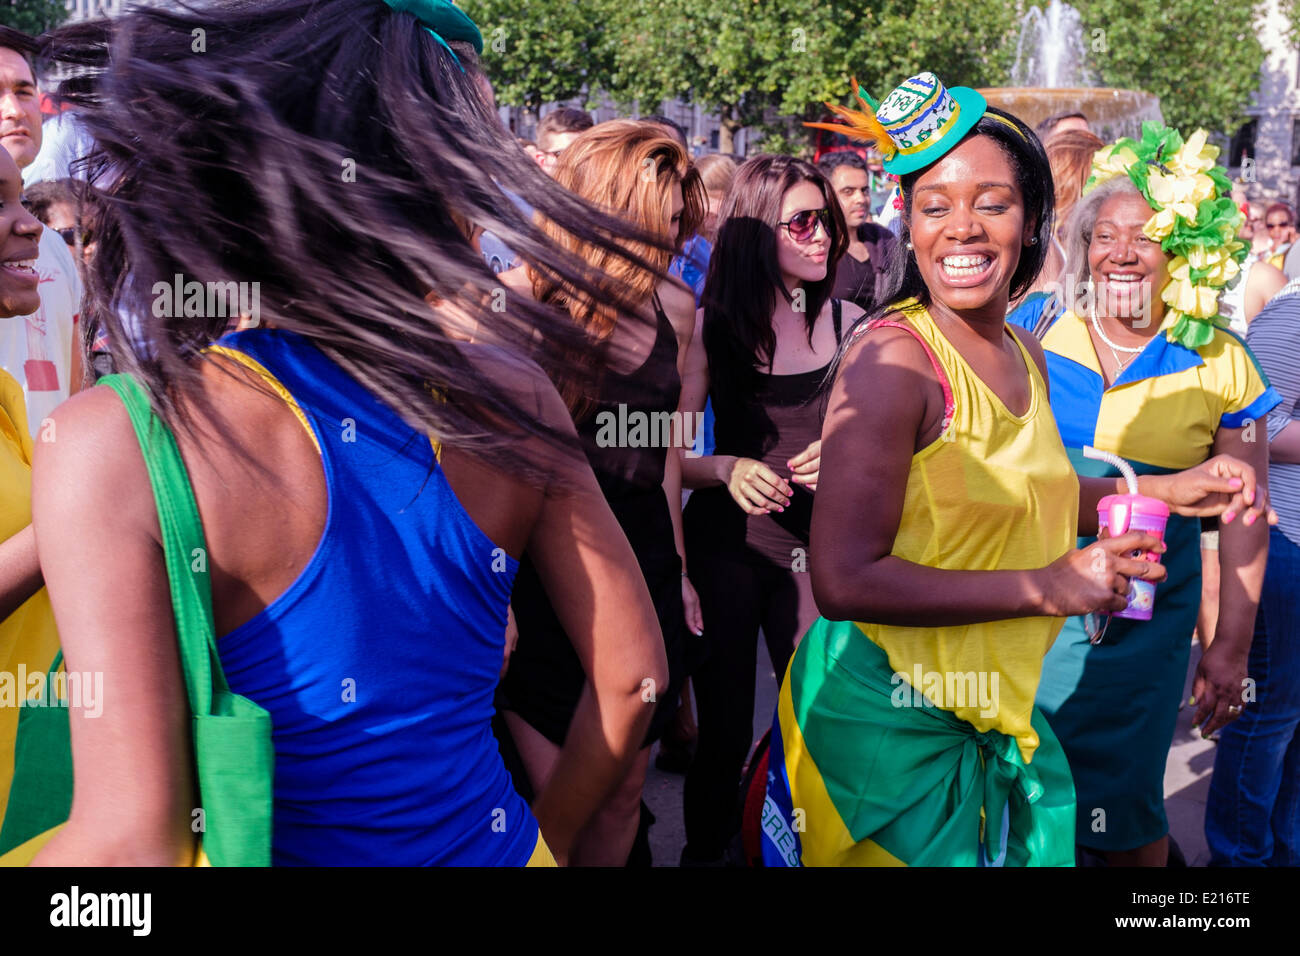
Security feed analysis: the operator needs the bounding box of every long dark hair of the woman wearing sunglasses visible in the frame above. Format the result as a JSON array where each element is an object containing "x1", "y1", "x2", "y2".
[{"x1": 702, "y1": 155, "x2": 849, "y2": 403}]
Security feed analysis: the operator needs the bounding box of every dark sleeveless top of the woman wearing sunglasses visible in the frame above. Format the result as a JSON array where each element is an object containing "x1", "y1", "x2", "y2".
[{"x1": 685, "y1": 299, "x2": 841, "y2": 570}]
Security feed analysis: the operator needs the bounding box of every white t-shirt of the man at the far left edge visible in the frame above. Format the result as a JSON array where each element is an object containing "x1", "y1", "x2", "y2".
[{"x1": 0, "y1": 229, "x2": 82, "y2": 438}]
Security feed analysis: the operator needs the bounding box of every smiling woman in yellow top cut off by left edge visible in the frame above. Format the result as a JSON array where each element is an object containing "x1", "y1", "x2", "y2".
[{"x1": 0, "y1": 143, "x2": 59, "y2": 821}]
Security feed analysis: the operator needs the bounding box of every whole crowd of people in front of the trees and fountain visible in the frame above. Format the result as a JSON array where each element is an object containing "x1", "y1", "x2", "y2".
[{"x1": 0, "y1": 0, "x2": 1300, "y2": 866}]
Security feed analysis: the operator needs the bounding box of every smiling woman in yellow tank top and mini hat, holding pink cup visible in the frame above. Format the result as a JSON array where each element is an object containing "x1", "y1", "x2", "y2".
[{"x1": 759, "y1": 73, "x2": 1264, "y2": 866}]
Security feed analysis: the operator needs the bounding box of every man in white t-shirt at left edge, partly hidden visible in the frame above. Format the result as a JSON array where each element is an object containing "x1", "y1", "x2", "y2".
[{"x1": 0, "y1": 27, "x2": 82, "y2": 437}]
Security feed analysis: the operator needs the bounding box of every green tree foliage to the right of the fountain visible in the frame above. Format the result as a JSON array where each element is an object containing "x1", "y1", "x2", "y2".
[{"x1": 1076, "y1": 0, "x2": 1264, "y2": 133}]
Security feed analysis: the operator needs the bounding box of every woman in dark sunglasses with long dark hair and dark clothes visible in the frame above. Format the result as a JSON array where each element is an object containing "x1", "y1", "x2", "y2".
[{"x1": 681, "y1": 156, "x2": 862, "y2": 865}]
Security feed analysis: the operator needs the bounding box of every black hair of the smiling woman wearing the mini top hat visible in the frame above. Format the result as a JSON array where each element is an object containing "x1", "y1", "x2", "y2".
[{"x1": 840, "y1": 107, "x2": 1056, "y2": 356}]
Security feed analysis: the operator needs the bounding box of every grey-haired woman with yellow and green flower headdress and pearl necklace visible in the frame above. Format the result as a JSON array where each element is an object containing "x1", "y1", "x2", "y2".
[{"x1": 1013, "y1": 122, "x2": 1279, "y2": 866}]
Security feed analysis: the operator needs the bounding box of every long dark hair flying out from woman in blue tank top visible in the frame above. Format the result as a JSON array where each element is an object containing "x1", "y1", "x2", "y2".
[{"x1": 42, "y1": 0, "x2": 670, "y2": 480}]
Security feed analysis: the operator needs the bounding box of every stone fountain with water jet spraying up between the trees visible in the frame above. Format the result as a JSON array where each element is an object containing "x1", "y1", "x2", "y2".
[{"x1": 980, "y1": 0, "x2": 1164, "y2": 143}]
